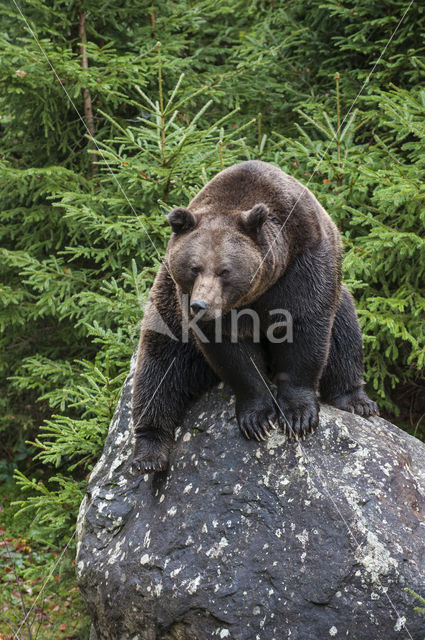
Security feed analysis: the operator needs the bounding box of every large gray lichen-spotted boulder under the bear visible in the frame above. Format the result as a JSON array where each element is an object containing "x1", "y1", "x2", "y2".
[{"x1": 77, "y1": 360, "x2": 425, "y2": 640}]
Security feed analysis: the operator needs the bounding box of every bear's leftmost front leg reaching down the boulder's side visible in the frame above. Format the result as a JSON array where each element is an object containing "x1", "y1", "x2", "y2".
[{"x1": 132, "y1": 265, "x2": 217, "y2": 473}]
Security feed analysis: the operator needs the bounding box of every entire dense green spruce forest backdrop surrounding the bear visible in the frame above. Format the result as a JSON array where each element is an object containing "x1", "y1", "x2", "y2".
[{"x1": 0, "y1": 0, "x2": 425, "y2": 604}]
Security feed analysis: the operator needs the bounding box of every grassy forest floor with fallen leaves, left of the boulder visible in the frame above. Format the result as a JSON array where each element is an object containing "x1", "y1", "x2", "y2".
[{"x1": 0, "y1": 484, "x2": 90, "y2": 640}]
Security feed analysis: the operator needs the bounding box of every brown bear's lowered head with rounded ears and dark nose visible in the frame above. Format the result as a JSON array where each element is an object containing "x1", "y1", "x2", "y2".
[{"x1": 167, "y1": 203, "x2": 269, "y2": 321}]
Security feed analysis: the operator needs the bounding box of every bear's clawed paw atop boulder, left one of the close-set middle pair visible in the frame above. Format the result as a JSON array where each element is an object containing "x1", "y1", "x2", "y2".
[{"x1": 236, "y1": 396, "x2": 279, "y2": 442}]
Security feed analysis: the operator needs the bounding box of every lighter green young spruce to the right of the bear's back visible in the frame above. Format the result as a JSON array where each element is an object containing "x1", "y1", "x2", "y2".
[{"x1": 272, "y1": 78, "x2": 425, "y2": 414}]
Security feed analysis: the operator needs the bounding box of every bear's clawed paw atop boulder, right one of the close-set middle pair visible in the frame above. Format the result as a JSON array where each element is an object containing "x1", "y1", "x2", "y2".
[{"x1": 277, "y1": 387, "x2": 319, "y2": 440}]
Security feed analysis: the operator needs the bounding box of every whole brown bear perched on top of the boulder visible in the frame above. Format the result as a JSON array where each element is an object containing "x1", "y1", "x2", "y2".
[{"x1": 133, "y1": 161, "x2": 377, "y2": 473}]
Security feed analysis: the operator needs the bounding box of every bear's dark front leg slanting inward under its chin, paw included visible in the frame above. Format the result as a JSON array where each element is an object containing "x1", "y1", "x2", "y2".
[{"x1": 195, "y1": 338, "x2": 279, "y2": 441}]
